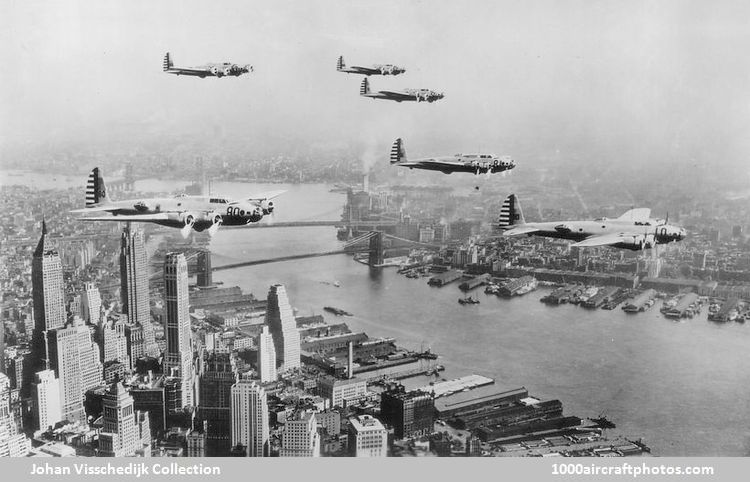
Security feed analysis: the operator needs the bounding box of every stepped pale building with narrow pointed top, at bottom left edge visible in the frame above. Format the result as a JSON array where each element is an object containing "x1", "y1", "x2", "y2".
[{"x1": 98, "y1": 380, "x2": 151, "y2": 457}]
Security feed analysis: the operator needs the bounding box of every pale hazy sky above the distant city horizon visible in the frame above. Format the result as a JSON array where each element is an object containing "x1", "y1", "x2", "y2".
[{"x1": 0, "y1": 0, "x2": 750, "y2": 171}]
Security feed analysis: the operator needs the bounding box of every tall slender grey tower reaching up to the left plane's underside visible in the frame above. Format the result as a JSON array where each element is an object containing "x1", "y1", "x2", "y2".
[{"x1": 120, "y1": 227, "x2": 159, "y2": 363}]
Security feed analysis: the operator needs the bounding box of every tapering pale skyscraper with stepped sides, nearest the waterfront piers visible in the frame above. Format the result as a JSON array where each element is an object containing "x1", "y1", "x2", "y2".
[{"x1": 266, "y1": 284, "x2": 300, "y2": 371}]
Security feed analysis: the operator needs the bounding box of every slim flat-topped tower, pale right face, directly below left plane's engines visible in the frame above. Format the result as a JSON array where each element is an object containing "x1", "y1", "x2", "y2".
[{"x1": 164, "y1": 253, "x2": 193, "y2": 407}]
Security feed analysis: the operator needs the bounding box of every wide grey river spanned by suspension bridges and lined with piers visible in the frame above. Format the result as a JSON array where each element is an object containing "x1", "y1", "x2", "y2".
[{"x1": 5, "y1": 173, "x2": 750, "y2": 456}]
